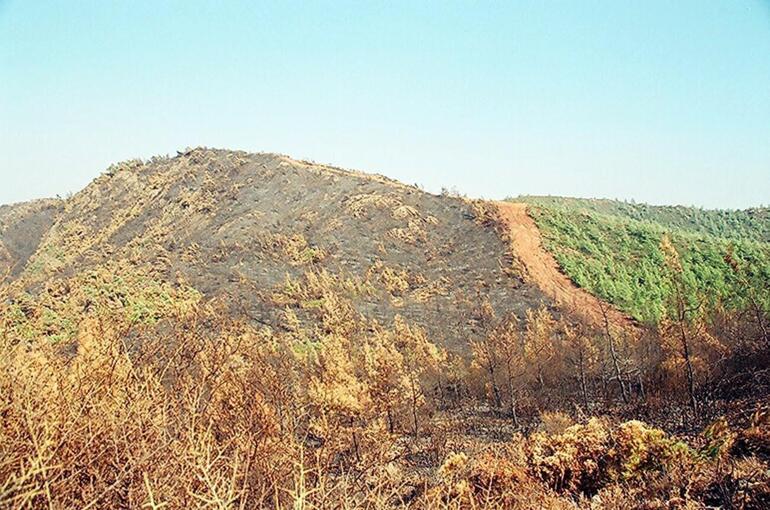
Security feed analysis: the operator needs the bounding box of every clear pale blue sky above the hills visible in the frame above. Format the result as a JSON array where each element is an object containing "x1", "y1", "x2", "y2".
[{"x1": 0, "y1": 0, "x2": 770, "y2": 208}]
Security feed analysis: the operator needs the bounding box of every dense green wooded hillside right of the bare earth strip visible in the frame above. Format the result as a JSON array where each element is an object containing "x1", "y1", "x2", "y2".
[{"x1": 510, "y1": 197, "x2": 770, "y2": 323}]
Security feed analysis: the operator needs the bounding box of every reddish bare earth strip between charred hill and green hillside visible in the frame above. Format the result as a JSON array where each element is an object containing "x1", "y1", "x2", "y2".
[{"x1": 497, "y1": 202, "x2": 633, "y2": 328}]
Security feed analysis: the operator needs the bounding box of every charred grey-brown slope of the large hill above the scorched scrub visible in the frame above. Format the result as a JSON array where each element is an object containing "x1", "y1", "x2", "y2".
[{"x1": 9, "y1": 149, "x2": 550, "y2": 349}]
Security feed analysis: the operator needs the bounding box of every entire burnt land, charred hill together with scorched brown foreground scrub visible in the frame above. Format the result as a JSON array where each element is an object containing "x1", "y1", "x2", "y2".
[{"x1": 0, "y1": 150, "x2": 770, "y2": 509}]
